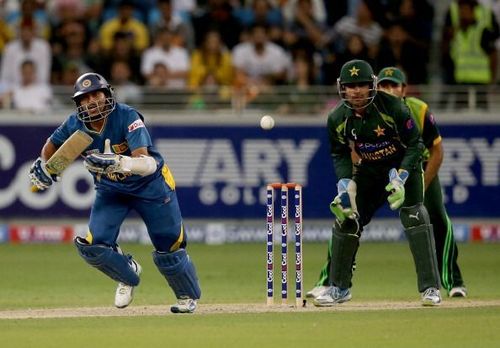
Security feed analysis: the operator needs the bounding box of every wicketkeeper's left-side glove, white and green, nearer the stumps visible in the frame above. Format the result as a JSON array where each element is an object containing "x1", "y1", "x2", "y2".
[{"x1": 330, "y1": 179, "x2": 359, "y2": 222}]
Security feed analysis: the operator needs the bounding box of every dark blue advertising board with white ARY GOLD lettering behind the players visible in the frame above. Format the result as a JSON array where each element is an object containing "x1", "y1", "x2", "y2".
[{"x1": 0, "y1": 124, "x2": 500, "y2": 220}]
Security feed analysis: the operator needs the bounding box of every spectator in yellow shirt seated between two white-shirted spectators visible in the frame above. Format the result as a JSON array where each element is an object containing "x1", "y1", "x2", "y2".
[{"x1": 189, "y1": 30, "x2": 233, "y2": 89}]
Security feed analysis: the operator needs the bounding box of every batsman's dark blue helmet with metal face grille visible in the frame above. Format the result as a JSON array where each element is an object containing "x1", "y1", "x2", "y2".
[{"x1": 72, "y1": 72, "x2": 116, "y2": 122}]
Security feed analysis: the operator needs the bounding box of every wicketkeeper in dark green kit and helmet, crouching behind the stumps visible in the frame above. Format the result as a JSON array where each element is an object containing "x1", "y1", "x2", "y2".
[{"x1": 313, "y1": 60, "x2": 441, "y2": 307}]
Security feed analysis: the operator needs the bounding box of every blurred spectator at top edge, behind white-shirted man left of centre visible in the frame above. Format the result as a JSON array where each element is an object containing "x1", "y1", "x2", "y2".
[{"x1": 149, "y1": 0, "x2": 194, "y2": 51}]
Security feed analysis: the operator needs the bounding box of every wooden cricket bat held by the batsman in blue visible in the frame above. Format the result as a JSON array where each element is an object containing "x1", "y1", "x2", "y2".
[{"x1": 31, "y1": 130, "x2": 94, "y2": 192}]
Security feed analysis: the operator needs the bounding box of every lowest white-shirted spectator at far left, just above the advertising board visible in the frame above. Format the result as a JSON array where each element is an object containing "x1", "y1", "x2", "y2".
[{"x1": 12, "y1": 60, "x2": 53, "y2": 113}]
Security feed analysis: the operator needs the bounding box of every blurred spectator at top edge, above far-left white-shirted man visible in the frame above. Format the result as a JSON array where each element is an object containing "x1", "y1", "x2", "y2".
[{"x1": 6, "y1": 0, "x2": 50, "y2": 39}]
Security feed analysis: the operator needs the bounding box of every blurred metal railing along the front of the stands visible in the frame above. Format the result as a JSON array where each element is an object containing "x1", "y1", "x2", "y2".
[{"x1": 1, "y1": 85, "x2": 500, "y2": 118}]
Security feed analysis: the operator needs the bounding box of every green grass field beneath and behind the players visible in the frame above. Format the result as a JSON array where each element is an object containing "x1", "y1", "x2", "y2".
[{"x1": 0, "y1": 243, "x2": 500, "y2": 348}]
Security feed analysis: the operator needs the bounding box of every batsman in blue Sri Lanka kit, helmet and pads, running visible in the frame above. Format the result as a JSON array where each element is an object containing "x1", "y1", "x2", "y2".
[{"x1": 29, "y1": 73, "x2": 201, "y2": 313}]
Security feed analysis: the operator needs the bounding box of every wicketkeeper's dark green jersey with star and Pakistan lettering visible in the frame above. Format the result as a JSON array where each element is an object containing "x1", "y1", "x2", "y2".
[{"x1": 328, "y1": 91, "x2": 425, "y2": 179}]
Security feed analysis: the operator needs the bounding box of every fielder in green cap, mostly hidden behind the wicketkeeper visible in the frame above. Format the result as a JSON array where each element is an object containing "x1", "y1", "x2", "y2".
[{"x1": 307, "y1": 67, "x2": 467, "y2": 298}]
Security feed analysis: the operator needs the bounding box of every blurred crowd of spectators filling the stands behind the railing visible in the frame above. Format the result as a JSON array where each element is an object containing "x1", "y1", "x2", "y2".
[{"x1": 0, "y1": 0, "x2": 499, "y2": 111}]
